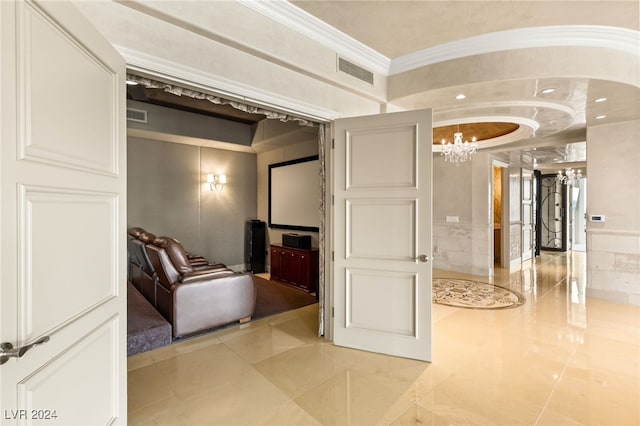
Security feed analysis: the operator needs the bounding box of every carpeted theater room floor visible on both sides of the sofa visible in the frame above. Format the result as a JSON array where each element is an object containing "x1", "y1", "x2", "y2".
[{"x1": 127, "y1": 275, "x2": 317, "y2": 356}]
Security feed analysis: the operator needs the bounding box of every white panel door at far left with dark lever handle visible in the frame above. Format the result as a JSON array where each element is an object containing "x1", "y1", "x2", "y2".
[{"x1": 0, "y1": 1, "x2": 127, "y2": 425}]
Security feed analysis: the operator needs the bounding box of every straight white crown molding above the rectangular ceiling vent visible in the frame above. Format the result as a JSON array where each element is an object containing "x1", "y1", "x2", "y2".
[{"x1": 236, "y1": 0, "x2": 391, "y2": 76}]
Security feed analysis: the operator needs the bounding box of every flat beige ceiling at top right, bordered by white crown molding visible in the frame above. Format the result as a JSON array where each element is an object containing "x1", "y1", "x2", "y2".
[{"x1": 291, "y1": 0, "x2": 640, "y2": 59}]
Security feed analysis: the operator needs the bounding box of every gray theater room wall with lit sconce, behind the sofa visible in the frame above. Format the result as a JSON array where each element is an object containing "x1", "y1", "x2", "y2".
[{"x1": 127, "y1": 137, "x2": 257, "y2": 266}]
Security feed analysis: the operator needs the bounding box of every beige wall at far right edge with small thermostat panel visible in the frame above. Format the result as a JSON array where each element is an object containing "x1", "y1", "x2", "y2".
[{"x1": 587, "y1": 121, "x2": 640, "y2": 305}]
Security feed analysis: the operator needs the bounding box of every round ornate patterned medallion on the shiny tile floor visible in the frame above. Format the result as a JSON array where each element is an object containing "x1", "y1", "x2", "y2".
[{"x1": 433, "y1": 278, "x2": 524, "y2": 309}]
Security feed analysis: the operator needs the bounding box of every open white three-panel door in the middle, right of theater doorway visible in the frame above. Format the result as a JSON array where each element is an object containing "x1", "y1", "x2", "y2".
[{"x1": 333, "y1": 110, "x2": 432, "y2": 361}]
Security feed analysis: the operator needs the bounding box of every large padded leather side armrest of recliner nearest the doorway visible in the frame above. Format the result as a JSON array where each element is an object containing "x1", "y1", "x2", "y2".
[{"x1": 173, "y1": 273, "x2": 256, "y2": 337}]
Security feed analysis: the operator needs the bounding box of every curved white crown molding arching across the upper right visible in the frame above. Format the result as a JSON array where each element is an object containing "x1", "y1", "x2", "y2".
[{"x1": 389, "y1": 25, "x2": 640, "y2": 75}]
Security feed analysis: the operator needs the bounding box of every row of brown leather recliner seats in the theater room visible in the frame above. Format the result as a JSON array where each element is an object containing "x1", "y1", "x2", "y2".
[{"x1": 130, "y1": 228, "x2": 256, "y2": 338}]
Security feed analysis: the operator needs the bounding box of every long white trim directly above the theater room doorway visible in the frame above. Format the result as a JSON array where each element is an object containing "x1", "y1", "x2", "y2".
[{"x1": 119, "y1": 45, "x2": 340, "y2": 122}]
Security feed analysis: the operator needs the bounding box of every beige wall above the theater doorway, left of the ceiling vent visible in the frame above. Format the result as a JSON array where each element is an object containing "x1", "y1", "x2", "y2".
[{"x1": 76, "y1": 1, "x2": 386, "y2": 118}]
